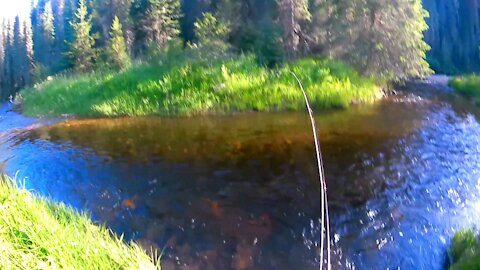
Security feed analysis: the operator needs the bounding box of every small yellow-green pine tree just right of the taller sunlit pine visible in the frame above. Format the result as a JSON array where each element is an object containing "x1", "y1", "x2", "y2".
[{"x1": 107, "y1": 16, "x2": 131, "y2": 69}]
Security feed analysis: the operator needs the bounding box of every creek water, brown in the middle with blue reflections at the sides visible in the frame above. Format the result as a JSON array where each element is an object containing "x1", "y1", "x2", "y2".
[{"x1": 0, "y1": 88, "x2": 480, "y2": 269}]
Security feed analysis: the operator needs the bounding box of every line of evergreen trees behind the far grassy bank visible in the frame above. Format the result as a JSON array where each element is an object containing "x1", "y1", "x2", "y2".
[{"x1": 0, "y1": 0, "x2": 429, "y2": 99}]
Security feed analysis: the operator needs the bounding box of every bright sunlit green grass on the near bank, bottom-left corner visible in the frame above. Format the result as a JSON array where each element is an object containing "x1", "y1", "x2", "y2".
[{"x1": 0, "y1": 178, "x2": 160, "y2": 269}]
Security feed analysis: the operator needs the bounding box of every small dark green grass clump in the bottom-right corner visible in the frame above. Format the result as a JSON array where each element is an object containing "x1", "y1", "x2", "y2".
[{"x1": 450, "y1": 229, "x2": 480, "y2": 270}]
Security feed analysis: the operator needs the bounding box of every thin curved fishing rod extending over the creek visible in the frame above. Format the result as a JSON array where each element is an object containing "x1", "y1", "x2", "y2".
[{"x1": 290, "y1": 71, "x2": 332, "y2": 270}]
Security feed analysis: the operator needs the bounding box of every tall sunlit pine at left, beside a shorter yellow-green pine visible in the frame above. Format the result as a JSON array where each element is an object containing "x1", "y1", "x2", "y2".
[{"x1": 69, "y1": 0, "x2": 97, "y2": 72}]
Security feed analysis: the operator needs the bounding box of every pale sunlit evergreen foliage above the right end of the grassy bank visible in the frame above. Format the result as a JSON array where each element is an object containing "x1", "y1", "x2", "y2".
[{"x1": 312, "y1": 0, "x2": 431, "y2": 79}]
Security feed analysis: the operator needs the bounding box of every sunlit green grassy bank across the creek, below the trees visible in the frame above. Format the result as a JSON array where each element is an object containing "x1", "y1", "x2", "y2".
[{"x1": 21, "y1": 55, "x2": 382, "y2": 117}]
